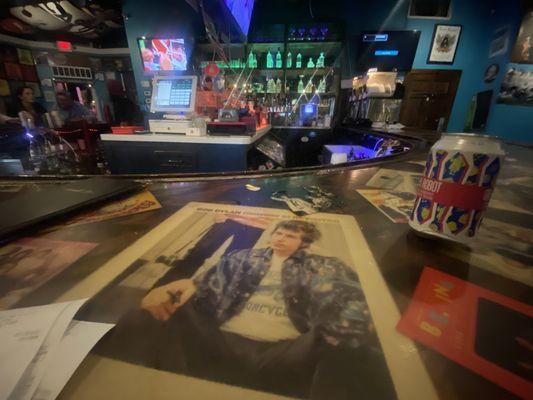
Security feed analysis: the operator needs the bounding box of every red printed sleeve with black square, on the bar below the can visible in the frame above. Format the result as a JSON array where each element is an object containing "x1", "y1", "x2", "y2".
[{"x1": 397, "y1": 267, "x2": 533, "y2": 398}]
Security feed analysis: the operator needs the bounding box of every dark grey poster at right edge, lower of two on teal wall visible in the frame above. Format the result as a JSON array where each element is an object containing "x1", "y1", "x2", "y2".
[{"x1": 498, "y1": 67, "x2": 533, "y2": 106}]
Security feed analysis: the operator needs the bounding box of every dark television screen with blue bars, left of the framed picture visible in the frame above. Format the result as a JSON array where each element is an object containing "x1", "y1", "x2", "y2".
[{"x1": 357, "y1": 31, "x2": 420, "y2": 72}]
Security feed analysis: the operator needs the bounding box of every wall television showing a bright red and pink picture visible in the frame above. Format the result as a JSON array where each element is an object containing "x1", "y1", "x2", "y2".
[{"x1": 139, "y1": 39, "x2": 187, "y2": 72}]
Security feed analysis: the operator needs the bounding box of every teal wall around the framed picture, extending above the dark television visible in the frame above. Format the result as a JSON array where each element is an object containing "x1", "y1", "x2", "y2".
[{"x1": 345, "y1": 0, "x2": 533, "y2": 143}]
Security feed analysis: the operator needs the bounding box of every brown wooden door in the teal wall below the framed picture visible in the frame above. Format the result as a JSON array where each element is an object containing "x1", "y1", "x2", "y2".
[{"x1": 400, "y1": 70, "x2": 461, "y2": 130}]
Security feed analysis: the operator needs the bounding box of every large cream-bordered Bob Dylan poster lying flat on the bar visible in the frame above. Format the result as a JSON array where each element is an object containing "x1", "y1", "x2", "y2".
[{"x1": 78, "y1": 203, "x2": 434, "y2": 399}]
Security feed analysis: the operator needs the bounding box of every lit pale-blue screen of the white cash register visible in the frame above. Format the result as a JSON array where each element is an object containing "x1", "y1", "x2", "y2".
[{"x1": 151, "y1": 76, "x2": 197, "y2": 113}]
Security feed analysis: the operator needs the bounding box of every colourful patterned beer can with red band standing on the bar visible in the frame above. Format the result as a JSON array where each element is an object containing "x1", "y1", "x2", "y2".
[{"x1": 409, "y1": 133, "x2": 505, "y2": 243}]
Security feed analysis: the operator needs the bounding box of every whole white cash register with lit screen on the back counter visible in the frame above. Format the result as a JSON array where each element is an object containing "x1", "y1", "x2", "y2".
[{"x1": 148, "y1": 75, "x2": 206, "y2": 136}]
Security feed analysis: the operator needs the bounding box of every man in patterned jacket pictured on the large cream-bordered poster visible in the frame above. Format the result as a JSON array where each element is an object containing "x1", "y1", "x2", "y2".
[{"x1": 104, "y1": 220, "x2": 390, "y2": 399}]
